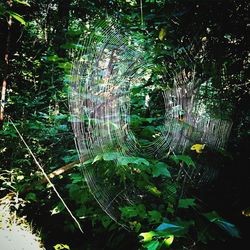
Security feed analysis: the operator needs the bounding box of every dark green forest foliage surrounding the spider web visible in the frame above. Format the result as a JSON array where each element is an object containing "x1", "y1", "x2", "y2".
[{"x1": 0, "y1": 0, "x2": 250, "y2": 250}]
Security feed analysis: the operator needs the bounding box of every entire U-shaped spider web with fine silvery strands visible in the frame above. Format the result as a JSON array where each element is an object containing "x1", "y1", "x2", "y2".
[{"x1": 69, "y1": 23, "x2": 231, "y2": 227}]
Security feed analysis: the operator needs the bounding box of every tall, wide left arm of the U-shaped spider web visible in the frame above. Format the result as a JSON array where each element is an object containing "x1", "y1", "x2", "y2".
[{"x1": 69, "y1": 21, "x2": 146, "y2": 227}]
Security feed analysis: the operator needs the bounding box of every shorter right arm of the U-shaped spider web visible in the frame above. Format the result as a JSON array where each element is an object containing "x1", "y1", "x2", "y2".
[{"x1": 164, "y1": 70, "x2": 232, "y2": 153}]
